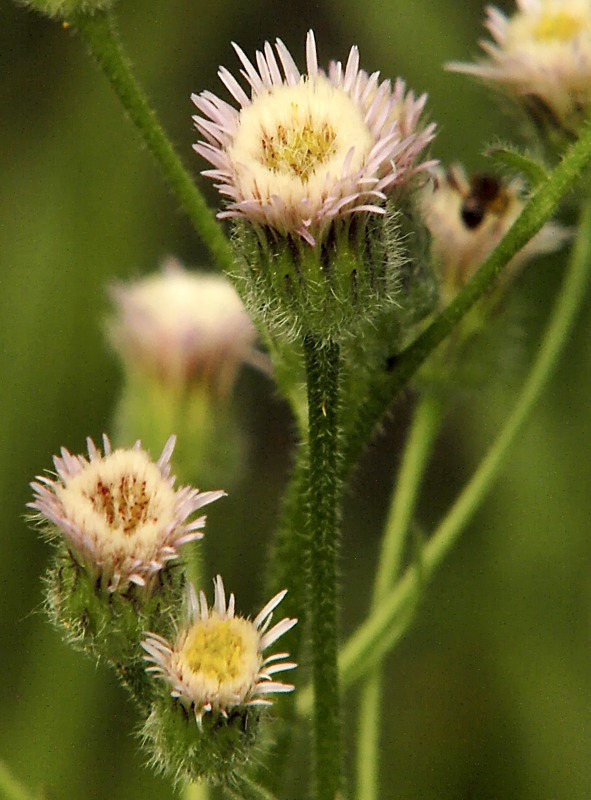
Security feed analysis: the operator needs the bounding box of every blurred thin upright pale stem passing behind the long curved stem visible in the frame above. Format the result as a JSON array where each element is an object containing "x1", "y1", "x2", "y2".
[{"x1": 356, "y1": 393, "x2": 443, "y2": 800}]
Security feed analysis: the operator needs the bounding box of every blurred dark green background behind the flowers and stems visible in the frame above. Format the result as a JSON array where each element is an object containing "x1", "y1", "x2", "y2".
[{"x1": 0, "y1": 0, "x2": 591, "y2": 800}]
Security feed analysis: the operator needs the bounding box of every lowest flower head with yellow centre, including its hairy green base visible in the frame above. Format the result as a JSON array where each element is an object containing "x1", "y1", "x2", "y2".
[{"x1": 142, "y1": 575, "x2": 297, "y2": 781}]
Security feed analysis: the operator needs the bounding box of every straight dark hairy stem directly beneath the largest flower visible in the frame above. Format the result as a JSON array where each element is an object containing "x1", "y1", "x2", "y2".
[{"x1": 304, "y1": 334, "x2": 342, "y2": 800}]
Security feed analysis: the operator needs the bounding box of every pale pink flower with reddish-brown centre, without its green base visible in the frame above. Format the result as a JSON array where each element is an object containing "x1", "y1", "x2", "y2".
[{"x1": 28, "y1": 436, "x2": 225, "y2": 591}]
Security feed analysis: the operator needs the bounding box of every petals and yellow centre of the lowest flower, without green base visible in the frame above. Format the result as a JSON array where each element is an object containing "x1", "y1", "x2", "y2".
[{"x1": 142, "y1": 575, "x2": 297, "y2": 727}]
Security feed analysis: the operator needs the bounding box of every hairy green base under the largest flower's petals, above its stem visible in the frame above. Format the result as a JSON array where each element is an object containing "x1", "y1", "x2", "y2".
[{"x1": 234, "y1": 204, "x2": 407, "y2": 342}]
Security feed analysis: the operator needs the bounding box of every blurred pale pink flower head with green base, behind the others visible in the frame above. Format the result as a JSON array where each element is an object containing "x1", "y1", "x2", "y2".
[{"x1": 109, "y1": 259, "x2": 269, "y2": 485}]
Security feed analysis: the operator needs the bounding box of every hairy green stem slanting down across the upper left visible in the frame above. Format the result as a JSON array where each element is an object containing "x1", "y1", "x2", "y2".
[{"x1": 70, "y1": 11, "x2": 233, "y2": 272}]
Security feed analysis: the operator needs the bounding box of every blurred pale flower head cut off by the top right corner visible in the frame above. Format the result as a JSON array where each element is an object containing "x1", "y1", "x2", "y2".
[{"x1": 449, "y1": 0, "x2": 591, "y2": 133}]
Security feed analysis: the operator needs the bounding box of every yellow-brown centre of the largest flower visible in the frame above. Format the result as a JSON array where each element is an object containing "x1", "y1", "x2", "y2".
[{"x1": 260, "y1": 109, "x2": 337, "y2": 182}]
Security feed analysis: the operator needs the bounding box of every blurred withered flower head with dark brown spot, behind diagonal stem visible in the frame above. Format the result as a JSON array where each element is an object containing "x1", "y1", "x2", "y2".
[{"x1": 422, "y1": 165, "x2": 568, "y2": 301}]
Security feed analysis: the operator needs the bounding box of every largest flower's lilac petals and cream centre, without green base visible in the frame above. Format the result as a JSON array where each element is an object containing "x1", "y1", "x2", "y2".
[{"x1": 192, "y1": 31, "x2": 435, "y2": 245}]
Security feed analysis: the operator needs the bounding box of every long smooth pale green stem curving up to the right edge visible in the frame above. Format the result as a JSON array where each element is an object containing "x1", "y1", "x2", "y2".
[{"x1": 298, "y1": 200, "x2": 591, "y2": 715}]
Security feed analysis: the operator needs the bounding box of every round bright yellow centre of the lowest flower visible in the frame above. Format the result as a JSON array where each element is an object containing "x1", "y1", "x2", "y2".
[{"x1": 181, "y1": 617, "x2": 249, "y2": 684}]
